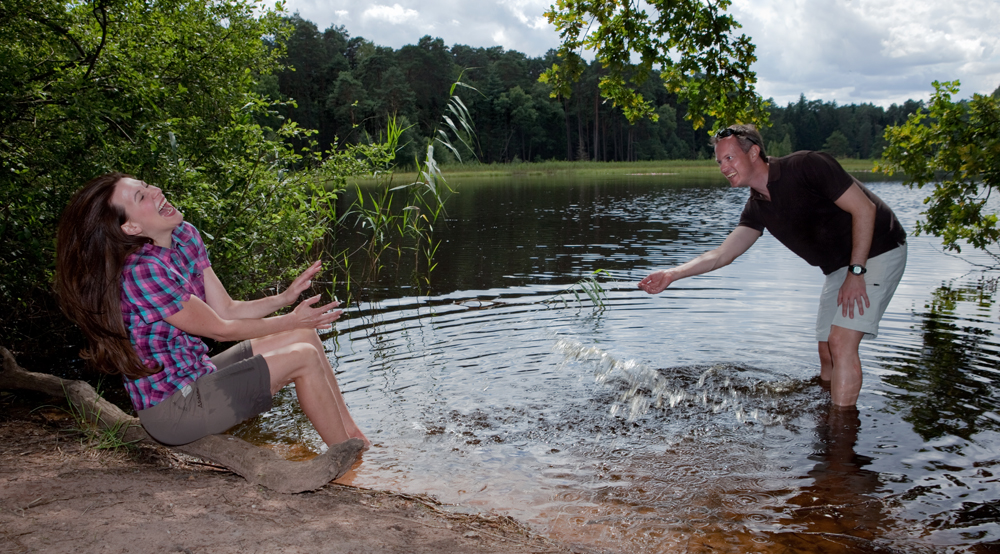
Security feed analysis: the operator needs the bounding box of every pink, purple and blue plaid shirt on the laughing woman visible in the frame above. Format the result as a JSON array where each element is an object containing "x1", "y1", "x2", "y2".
[{"x1": 121, "y1": 222, "x2": 216, "y2": 410}]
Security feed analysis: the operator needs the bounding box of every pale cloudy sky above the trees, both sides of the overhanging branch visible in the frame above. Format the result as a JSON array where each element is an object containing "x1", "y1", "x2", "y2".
[{"x1": 286, "y1": 0, "x2": 1000, "y2": 106}]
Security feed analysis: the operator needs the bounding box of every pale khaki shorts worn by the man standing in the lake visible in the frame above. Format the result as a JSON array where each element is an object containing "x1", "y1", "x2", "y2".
[{"x1": 816, "y1": 244, "x2": 906, "y2": 342}]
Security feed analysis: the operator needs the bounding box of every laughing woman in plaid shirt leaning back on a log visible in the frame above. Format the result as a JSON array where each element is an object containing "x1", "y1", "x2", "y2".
[{"x1": 56, "y1": 173, "x2": 370, "y2": 448}]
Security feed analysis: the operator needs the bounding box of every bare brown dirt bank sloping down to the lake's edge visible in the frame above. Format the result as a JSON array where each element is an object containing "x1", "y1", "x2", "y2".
[{"x1": 0, "y1": 393, "x2": 571, "y2": 554}]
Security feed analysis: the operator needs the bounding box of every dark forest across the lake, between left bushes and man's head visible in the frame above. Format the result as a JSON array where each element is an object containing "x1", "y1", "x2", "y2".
[{"x1": 278, "y1": 17, "x2": 740, "y2": 164}]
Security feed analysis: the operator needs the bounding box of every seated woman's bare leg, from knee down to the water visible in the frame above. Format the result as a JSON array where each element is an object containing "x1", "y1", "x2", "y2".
[{"x1": 250, "y1": 329, "x2": 371, "y2": 449}]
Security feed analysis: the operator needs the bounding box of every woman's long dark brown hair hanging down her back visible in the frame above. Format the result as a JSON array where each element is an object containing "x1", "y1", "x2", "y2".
[{"x1": 56, "y1": 173, "x2": 160, "y2": 379}]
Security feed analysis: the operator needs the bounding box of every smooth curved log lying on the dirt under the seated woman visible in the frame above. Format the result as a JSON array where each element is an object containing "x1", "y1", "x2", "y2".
[{"x1": 0, "y1": 347, "x2": 364, "y2": 493}]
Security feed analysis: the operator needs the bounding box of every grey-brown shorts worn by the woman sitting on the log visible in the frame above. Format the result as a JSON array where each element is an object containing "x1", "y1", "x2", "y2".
[{"x1": 139, "y1": 341, "x2": 271, "y2": 445}]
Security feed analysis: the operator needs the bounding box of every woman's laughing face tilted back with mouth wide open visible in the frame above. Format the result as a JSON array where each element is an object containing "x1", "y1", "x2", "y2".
[{"x1": 111, "y1": 177, "x2": 184, "y2": 248}]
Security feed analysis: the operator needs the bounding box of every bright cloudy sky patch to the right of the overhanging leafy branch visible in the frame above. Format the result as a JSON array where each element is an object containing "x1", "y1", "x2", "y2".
[{"x1": 733, "y1": 0, "x2": 1000, "y2": 105}]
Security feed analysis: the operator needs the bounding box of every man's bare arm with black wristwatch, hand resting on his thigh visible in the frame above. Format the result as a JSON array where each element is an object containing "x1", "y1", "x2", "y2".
[{"x1": 835, "y1": 184, "x2": 875, "y2": 319}]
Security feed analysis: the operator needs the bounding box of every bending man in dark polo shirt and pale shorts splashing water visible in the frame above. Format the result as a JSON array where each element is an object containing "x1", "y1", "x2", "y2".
[{"x1": 639, "y1": 125, "x2": 906, "y2": 406}]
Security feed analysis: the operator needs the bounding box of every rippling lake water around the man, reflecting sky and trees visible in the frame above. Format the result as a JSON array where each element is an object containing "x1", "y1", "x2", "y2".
[{"x1": 242, "y1": 170, "x2": 1000, "y2": 553}]
